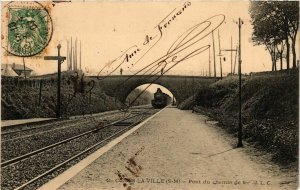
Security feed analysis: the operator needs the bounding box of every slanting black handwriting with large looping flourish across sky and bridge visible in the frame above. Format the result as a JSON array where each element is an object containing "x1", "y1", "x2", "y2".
[{"x1": 97, "y1": 2, "x2": 225, "y2": 108}]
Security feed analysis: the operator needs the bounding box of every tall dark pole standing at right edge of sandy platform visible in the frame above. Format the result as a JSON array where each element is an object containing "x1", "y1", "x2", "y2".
[{"x1": 237, "y1": 18, "x2": 243, "y2": 147}]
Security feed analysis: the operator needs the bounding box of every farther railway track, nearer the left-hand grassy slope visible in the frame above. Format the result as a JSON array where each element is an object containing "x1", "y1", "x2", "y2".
[{"x1": 1, "y1": 113, "x2": 135, "y2": 163}]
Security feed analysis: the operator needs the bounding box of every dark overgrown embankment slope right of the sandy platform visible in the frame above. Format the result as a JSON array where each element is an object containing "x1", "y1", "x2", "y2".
[{"x1": 179, "y1": 69, "x2": 299, "y2": 164}]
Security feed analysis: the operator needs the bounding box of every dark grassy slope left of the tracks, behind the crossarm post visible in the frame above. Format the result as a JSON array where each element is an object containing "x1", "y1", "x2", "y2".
[{"x1": 1, "y1": 85, "x2": 121, "y2": 119}]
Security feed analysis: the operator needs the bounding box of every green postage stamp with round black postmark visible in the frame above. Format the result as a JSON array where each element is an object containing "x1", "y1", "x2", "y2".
[{"x1": 5, "y1": 2, "x2": 52, "y2": 57}]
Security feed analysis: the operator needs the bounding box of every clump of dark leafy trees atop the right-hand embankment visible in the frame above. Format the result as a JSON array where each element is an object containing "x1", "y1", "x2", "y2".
[{"x1": 249, "y1": 1, "x2": 299, "y2": 70}]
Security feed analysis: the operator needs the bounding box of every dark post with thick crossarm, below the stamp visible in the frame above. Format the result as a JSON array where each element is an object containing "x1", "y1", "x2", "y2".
[{"x1": 44, "y1": 44, "x2": 66, "y2": 118}]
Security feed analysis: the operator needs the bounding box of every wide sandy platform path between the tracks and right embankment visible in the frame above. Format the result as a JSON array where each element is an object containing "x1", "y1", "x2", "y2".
[{"x1": 59, "y1": 108, "x2": 298, "y2": 190}]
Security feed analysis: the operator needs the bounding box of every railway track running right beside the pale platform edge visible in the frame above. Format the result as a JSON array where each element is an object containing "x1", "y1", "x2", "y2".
[{"x1": 1, "y1": 107, "x2": 156, "y2": 189}]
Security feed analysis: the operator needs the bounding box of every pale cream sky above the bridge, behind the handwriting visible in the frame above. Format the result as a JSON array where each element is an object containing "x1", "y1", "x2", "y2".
[{"x1": 1, "y1": 0, "x2": 299, "y2": 75}]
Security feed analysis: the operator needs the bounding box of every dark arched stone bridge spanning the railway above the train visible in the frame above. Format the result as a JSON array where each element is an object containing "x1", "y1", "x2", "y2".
[{"x1": 90, "y1": 75, "x2": 218, "y2": 103}]
